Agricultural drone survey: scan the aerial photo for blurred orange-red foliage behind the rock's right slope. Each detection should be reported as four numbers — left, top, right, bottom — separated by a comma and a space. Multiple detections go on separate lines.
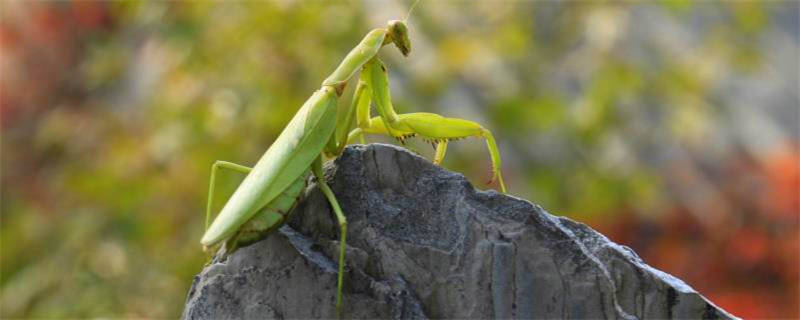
591, 146, 800, 318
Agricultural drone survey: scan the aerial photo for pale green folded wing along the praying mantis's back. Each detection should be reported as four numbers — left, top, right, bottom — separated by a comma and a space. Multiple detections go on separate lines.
200, 86, 336, 247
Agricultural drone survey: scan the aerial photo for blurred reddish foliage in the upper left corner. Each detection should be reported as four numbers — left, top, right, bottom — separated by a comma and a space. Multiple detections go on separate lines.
0, 1, 112, 127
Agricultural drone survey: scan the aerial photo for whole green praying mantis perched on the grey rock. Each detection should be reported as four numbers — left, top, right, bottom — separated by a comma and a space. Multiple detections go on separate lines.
205, 15, 506, 317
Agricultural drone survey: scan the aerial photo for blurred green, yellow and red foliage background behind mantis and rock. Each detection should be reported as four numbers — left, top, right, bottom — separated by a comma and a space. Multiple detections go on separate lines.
0, 1, 800, 318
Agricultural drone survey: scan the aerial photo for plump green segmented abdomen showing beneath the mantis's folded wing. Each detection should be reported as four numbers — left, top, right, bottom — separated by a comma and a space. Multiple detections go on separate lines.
225, 169, 311, 252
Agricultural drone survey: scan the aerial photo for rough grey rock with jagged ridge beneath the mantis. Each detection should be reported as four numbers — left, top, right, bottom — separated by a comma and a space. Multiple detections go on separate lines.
183, 144, 733, 319
